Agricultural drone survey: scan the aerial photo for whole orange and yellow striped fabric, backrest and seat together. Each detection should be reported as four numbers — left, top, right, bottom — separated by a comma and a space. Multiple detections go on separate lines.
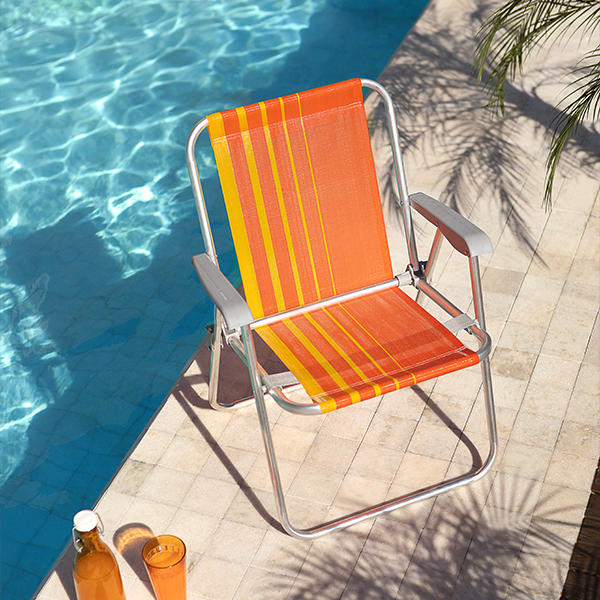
208, 79, 478, 412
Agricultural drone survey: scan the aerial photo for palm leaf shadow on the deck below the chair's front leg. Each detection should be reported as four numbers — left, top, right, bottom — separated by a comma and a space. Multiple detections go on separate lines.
263, 478, 577, 600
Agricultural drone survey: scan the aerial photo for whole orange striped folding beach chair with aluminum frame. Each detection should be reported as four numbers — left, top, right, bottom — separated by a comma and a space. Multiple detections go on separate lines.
187, 79, 497, 538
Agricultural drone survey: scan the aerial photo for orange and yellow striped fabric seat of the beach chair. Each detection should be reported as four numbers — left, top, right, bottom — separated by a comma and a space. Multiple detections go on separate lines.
256, 288, 479, 413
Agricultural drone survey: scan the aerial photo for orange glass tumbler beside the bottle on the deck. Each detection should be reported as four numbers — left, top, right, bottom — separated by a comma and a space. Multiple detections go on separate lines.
142, 535, 187, 600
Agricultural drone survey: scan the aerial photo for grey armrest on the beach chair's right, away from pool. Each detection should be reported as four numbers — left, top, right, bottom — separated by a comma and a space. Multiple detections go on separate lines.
409, 192, 494, 256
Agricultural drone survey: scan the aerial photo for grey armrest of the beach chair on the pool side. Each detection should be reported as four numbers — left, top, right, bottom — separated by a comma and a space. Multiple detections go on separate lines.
192, 254, 254, 329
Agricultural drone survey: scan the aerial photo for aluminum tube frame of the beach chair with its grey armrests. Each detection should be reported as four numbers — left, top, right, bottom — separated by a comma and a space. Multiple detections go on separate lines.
186, 79, 498, 539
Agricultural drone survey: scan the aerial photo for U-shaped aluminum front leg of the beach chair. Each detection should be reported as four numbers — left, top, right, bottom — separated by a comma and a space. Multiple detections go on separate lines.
242, 327, 498, 539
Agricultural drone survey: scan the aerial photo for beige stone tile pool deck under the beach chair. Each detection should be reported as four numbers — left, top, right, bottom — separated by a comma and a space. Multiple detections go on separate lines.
37, 0, 600, 600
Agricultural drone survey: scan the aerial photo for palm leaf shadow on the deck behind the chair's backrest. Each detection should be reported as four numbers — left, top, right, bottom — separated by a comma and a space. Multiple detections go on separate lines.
369, 2, 600, 260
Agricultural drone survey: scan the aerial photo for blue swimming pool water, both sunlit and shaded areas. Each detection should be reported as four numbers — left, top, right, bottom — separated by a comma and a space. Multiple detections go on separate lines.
0, 0, 426, 600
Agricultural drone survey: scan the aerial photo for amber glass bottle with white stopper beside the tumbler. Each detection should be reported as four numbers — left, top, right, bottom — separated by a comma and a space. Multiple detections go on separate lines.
73, 510, 125, 600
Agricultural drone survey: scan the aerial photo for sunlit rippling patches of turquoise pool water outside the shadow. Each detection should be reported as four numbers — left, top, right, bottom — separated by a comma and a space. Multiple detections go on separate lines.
0, 0, 324, 484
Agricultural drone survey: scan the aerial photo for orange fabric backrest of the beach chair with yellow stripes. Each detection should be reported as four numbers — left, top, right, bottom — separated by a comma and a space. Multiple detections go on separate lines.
207, 79, 393, 319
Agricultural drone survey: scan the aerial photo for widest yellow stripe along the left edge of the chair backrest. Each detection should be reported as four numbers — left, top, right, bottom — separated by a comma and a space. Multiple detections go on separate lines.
208, 113, 264, 318
